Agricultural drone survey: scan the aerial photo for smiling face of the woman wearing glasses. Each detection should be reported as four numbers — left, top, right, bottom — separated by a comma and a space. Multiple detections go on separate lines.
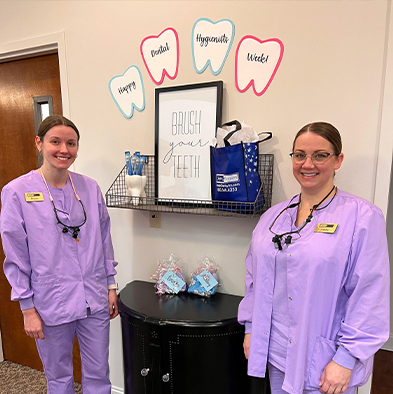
293, 132, 344, 195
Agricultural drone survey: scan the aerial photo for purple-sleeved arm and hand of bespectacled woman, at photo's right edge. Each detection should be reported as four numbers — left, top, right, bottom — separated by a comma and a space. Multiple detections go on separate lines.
320, 207, 389, 393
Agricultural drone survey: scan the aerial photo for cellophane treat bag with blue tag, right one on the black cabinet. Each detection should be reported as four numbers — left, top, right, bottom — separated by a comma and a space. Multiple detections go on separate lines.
188, 257, 218, 297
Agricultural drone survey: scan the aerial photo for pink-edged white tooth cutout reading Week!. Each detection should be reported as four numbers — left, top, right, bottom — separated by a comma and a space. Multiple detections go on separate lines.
235, 36, 284, 96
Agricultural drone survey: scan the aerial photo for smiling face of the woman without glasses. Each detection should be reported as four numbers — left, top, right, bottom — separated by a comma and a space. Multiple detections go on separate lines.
35, 125, 78, 171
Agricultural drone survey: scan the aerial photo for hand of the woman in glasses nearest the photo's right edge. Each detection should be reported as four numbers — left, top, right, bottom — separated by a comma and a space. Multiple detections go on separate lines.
319, 360, 352, 394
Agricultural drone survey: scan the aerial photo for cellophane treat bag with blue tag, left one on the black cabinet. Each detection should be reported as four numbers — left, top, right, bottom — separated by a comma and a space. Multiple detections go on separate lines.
150, 253, 187, 294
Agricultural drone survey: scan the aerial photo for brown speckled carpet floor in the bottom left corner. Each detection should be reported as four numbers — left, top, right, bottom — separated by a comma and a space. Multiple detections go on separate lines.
0, 361, 82, 394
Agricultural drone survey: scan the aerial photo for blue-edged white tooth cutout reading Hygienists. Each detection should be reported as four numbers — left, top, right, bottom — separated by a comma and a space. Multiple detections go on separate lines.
192, 18, 235, 75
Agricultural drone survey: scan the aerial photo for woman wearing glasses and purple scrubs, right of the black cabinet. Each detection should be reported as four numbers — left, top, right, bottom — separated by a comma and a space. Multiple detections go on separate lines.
238, 122, 389, 394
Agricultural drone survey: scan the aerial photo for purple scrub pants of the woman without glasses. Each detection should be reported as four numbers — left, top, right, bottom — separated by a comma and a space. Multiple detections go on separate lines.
36, 309, 111, 394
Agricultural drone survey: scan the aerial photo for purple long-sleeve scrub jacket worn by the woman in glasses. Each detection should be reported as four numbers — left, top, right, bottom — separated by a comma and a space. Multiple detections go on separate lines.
238, 190, 390, 394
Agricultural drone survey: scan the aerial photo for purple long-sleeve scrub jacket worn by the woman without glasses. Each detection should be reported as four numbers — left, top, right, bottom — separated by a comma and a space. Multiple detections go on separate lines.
0, 171, 117, 326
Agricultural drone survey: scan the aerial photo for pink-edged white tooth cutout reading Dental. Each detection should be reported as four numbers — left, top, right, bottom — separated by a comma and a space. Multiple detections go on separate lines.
140, 27, 179, 85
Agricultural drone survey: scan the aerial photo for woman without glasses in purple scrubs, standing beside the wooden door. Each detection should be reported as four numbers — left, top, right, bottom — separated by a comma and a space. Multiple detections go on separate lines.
0, 115, 118, 394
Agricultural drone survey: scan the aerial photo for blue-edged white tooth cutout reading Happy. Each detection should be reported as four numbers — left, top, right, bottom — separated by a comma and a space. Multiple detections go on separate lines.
109, 66, 145, 118
